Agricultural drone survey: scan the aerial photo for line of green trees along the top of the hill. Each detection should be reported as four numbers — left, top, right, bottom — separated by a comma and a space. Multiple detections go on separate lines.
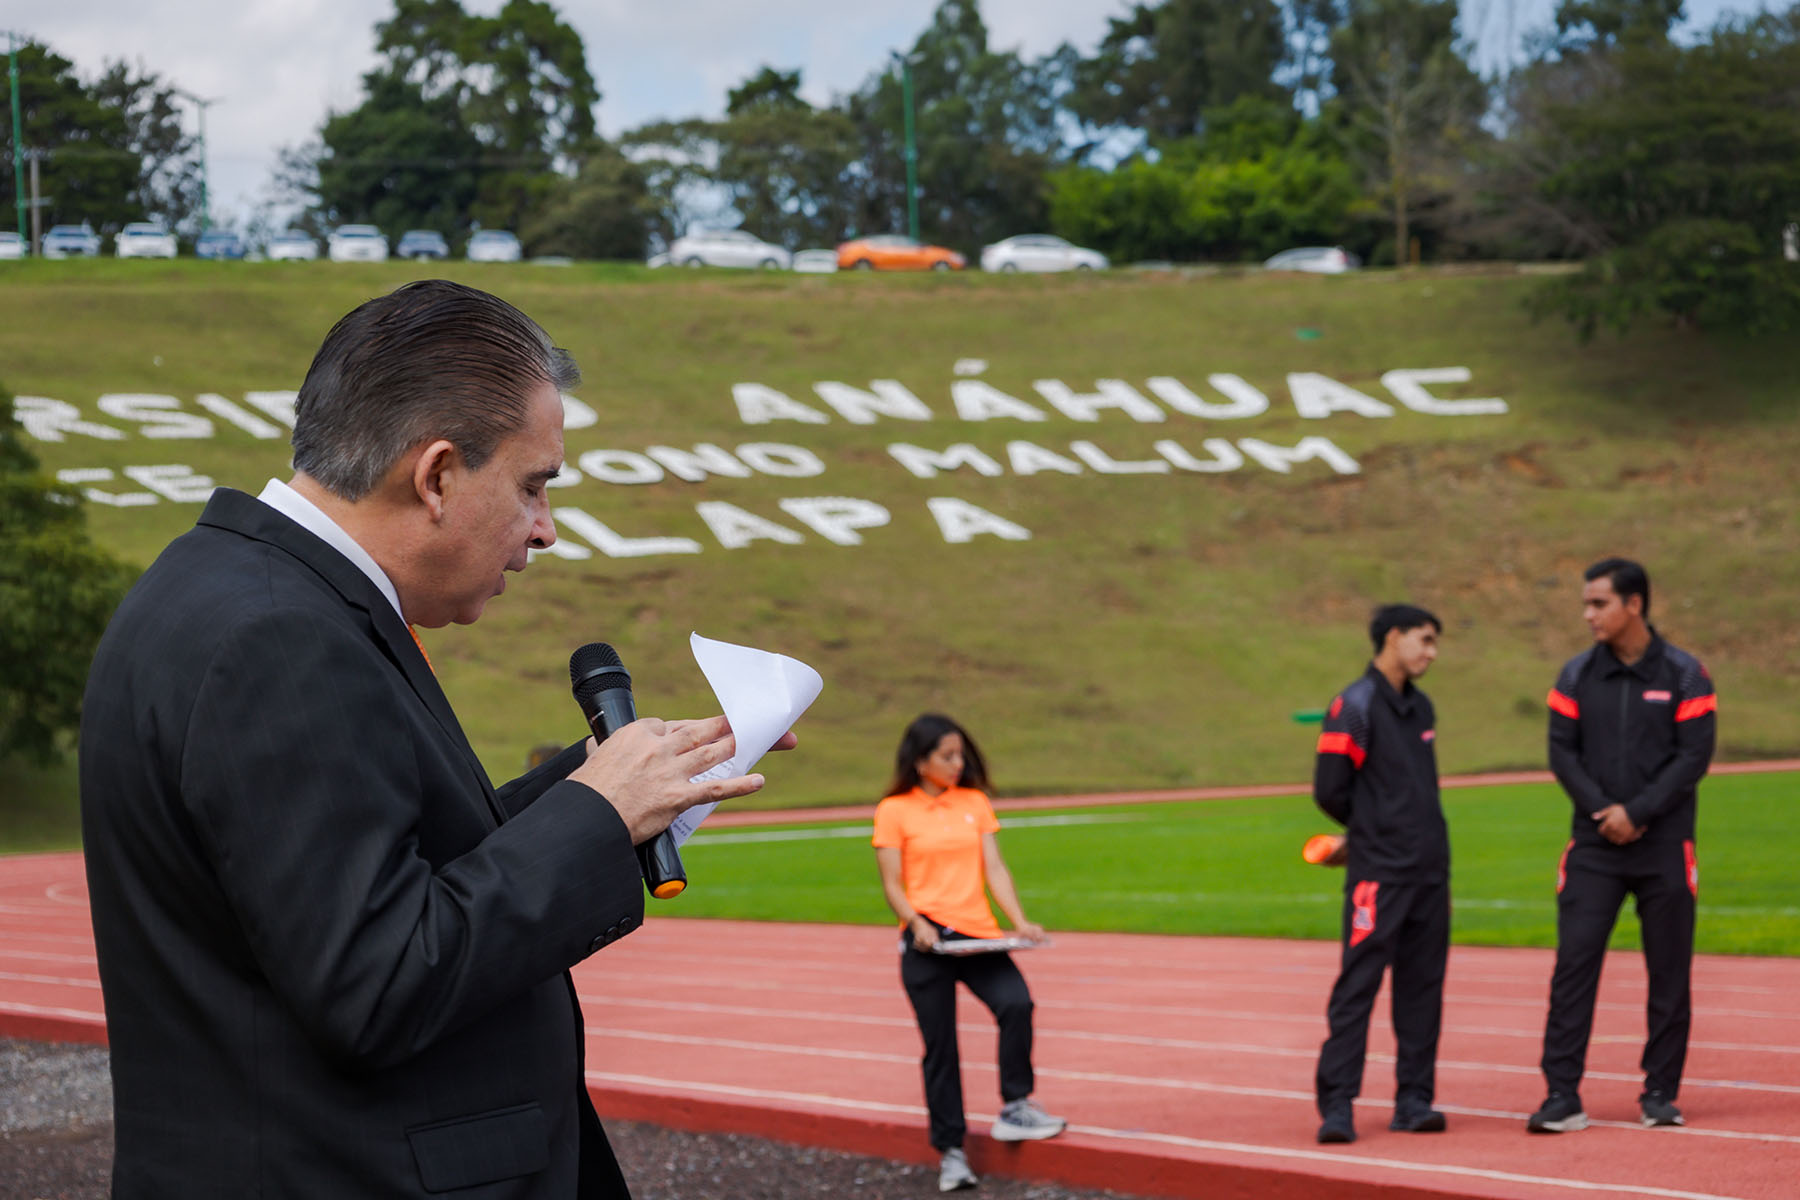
4, 0, 1800, 331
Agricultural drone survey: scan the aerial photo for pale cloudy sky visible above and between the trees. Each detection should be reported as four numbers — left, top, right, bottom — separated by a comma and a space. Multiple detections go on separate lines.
10, 0, 1775, 221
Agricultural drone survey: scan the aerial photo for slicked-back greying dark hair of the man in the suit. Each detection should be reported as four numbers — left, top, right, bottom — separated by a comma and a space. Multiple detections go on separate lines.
293, 279, 581, 500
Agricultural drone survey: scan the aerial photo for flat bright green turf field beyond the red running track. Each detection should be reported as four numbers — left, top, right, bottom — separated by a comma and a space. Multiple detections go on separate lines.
673, 774, 1800, 955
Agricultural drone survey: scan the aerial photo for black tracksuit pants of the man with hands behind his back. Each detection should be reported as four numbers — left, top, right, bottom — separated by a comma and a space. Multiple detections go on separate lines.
1314, 880, 1451, 1115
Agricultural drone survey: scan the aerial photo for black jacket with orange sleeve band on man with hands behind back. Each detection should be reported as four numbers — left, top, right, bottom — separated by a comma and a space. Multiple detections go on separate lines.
1312, 664, 1451, 883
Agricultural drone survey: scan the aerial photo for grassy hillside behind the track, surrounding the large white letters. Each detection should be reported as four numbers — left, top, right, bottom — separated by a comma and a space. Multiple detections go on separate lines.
0, 261, 1800, 840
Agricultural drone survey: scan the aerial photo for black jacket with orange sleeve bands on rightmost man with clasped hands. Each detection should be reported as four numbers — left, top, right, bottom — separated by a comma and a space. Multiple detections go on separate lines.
1548, 628, 1719, 851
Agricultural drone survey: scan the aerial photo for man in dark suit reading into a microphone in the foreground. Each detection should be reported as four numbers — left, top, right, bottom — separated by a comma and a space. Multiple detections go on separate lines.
81, 281, 790, 1200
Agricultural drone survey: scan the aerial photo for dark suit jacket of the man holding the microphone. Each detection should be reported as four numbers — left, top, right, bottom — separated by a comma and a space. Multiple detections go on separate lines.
81, 489, 644, 1200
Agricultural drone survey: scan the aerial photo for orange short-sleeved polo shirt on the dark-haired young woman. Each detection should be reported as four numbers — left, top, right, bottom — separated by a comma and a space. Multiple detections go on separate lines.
873, 788, 1001, 937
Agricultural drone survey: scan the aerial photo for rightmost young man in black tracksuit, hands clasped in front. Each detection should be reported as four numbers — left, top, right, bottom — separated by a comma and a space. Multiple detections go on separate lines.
1526, 558, 1717, 1133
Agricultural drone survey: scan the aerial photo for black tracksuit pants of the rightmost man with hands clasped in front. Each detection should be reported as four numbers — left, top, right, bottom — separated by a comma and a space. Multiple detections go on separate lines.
1543, 842, 1699, 1099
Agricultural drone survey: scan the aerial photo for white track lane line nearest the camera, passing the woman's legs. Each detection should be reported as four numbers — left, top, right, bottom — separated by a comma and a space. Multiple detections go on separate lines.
587, 1070, 1742, 1200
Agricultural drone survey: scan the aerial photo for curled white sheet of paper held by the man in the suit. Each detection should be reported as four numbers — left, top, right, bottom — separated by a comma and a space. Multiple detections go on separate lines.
670, 633, 824, 846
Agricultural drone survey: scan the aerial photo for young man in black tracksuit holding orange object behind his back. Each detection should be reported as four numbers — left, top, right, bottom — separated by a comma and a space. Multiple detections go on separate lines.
1312, 604, 1451, 1142
